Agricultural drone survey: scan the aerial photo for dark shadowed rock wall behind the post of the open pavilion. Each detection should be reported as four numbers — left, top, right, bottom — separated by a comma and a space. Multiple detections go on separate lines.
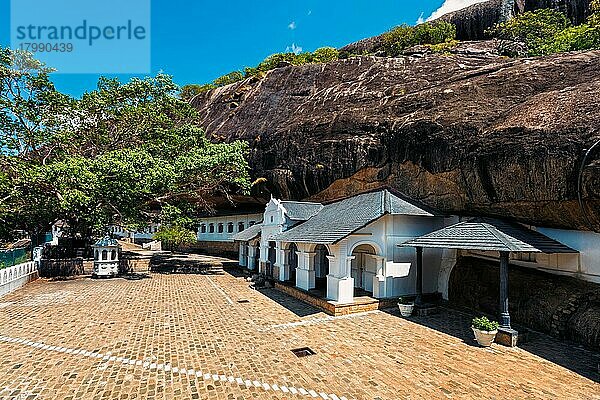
449, 257, 600, 350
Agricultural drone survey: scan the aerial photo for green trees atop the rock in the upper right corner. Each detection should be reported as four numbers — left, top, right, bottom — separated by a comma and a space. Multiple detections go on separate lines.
488, 5, 600, 56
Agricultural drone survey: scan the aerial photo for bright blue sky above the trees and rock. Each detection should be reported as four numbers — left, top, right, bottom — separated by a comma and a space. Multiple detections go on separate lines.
0, 0, 482, 96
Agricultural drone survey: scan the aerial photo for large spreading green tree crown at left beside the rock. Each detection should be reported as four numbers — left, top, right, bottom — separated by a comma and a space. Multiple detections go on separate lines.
0, 49, 249, 241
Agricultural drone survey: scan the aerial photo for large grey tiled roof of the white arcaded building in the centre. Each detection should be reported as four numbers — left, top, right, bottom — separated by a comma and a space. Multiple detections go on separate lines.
272, 190, 433, 244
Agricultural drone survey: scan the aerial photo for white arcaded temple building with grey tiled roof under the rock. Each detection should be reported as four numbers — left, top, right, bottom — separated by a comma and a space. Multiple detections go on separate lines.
234, 190, 455, 303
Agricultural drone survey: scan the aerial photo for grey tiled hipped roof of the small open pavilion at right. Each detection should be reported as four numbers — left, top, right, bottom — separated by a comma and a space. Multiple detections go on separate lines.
399, 218, 577, 254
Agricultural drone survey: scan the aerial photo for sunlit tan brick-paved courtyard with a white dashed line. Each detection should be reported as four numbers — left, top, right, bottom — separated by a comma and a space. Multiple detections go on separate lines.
0, 274, 600, 400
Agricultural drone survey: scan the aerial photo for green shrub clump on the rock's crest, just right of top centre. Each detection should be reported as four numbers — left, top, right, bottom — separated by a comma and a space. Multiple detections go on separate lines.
382, 21, 456, 57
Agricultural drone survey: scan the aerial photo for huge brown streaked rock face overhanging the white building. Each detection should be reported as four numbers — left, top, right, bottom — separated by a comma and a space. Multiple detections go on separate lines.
193, 42, 600, 230
